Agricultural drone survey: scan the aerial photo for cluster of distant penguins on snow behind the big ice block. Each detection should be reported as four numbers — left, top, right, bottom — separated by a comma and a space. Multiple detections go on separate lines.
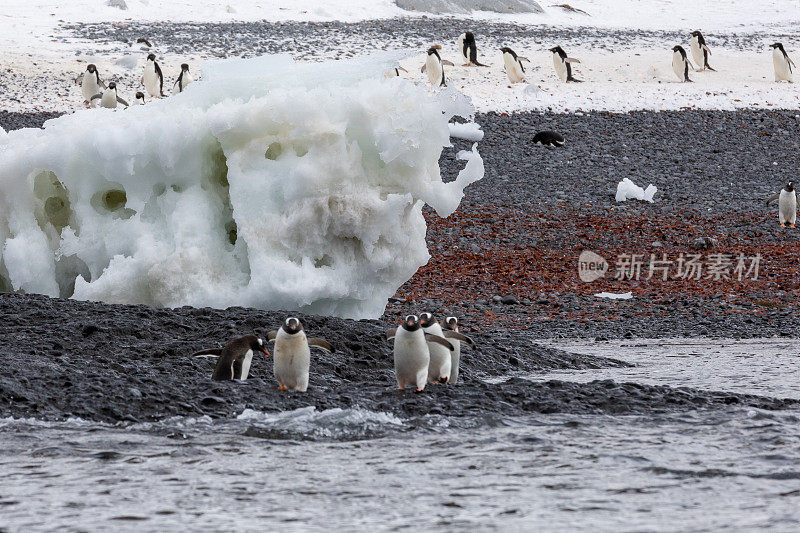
75, 53, 195, 109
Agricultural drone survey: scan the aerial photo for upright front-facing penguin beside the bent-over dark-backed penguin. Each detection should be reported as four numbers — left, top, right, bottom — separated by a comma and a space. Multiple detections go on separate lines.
267, 317, 333, 392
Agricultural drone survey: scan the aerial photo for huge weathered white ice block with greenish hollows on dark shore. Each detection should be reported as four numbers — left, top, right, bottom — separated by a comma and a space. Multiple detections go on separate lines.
0, 53, 483, 318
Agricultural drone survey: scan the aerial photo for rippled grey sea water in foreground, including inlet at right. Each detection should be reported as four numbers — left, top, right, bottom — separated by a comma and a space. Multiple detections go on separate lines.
0, 339, 800, 531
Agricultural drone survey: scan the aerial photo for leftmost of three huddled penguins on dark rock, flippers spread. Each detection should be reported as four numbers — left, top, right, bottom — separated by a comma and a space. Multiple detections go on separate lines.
386, 315, 453, 391
